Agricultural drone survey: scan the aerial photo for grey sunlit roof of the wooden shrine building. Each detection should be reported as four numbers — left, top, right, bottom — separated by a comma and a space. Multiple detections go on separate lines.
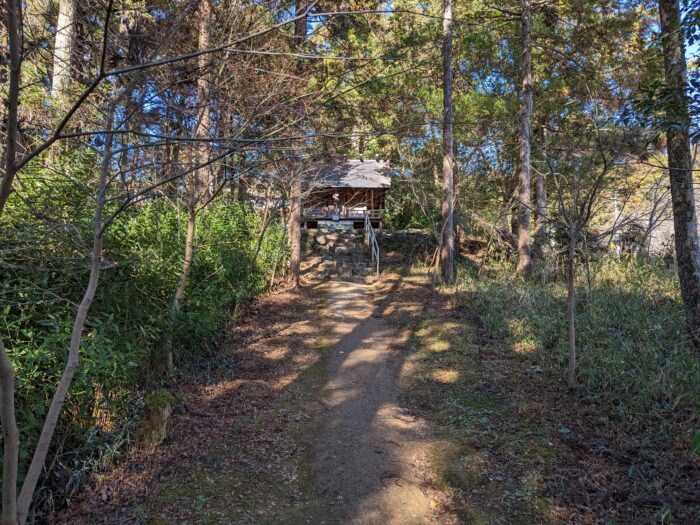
314, 159, 391, 189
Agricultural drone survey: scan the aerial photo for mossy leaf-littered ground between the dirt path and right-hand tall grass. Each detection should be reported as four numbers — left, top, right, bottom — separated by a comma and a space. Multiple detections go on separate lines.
394, 266, 700, 524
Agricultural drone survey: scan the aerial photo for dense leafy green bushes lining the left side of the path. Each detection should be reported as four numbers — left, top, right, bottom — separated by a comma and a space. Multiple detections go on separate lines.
0, 155, 287, 499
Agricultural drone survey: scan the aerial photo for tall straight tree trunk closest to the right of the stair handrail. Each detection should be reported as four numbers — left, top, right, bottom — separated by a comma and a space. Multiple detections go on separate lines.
440, 0, 455, 285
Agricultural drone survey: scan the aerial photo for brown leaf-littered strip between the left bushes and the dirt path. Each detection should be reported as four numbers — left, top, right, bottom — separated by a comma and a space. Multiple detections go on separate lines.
59, 286, 330, 525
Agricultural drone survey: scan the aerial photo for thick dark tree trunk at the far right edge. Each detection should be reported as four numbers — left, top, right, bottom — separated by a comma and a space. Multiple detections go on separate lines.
659, 0, 700, 350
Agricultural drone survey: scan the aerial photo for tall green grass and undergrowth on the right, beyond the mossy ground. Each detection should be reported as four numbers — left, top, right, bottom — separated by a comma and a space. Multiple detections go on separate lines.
460, 257, 700, 430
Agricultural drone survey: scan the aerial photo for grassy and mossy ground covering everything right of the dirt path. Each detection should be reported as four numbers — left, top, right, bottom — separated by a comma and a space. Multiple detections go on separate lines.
395, 253, 700, 524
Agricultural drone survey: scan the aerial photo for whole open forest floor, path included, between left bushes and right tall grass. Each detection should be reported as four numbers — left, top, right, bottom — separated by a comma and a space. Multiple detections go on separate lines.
56, 258, 699, 525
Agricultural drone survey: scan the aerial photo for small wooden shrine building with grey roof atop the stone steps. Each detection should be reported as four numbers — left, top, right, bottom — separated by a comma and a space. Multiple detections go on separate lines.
302, 159, 391, 228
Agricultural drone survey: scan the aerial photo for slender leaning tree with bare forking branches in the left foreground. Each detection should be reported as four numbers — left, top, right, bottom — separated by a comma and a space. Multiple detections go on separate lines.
0, 0, 318, 525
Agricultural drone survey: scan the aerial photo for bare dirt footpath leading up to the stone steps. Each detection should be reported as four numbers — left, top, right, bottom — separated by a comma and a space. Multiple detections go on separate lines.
311, 281, 432, 525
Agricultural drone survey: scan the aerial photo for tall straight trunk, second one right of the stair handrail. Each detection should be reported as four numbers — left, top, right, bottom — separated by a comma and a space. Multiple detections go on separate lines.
518, 0, 532, 275
